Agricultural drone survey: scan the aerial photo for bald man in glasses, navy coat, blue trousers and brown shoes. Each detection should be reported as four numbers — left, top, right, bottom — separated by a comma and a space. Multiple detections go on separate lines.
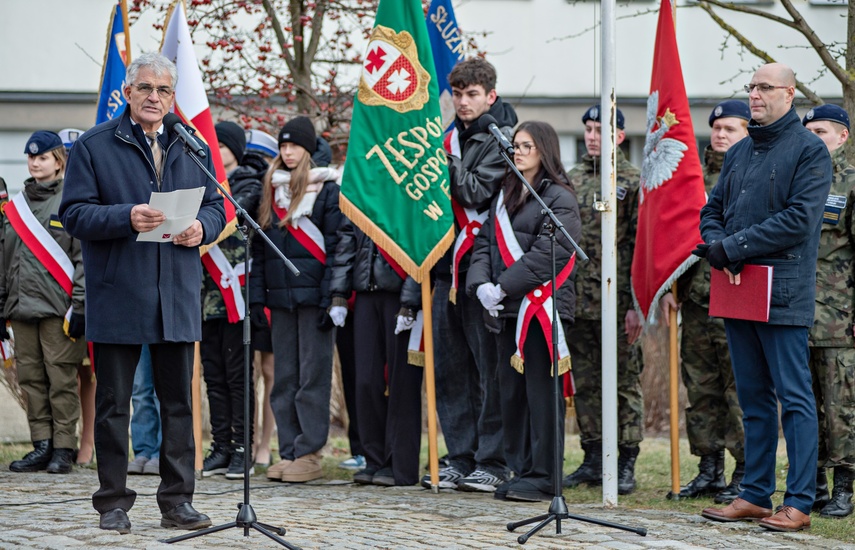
696, 63, 831, 531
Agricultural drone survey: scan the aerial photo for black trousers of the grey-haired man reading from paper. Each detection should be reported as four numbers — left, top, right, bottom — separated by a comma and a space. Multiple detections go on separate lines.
92, 343, 196, 513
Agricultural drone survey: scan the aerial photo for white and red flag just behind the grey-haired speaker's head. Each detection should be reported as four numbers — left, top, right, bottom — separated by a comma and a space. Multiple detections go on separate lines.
160, 0, 237, 236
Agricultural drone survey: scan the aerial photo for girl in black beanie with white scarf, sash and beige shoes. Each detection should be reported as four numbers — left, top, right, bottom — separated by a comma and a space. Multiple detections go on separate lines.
249, 117, 342, 483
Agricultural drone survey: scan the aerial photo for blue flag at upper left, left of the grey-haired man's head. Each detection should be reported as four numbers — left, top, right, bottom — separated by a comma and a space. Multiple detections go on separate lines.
95, 2, 129, 124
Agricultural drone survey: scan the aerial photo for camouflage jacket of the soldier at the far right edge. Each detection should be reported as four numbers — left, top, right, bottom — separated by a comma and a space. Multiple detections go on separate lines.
809, 147, 855, 347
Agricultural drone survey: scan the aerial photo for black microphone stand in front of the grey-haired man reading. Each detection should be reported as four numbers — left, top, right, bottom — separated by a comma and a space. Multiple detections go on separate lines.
162, 143, 300, 550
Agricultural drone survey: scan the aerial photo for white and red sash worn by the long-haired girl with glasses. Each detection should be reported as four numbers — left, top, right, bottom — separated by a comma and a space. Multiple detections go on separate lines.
496, 191, 576, 382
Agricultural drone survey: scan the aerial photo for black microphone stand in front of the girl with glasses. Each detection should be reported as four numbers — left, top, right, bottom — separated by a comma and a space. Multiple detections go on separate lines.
488, 144, 647, 544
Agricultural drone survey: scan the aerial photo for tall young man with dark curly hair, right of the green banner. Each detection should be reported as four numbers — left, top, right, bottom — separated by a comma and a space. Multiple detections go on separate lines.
422, 58, 517, 492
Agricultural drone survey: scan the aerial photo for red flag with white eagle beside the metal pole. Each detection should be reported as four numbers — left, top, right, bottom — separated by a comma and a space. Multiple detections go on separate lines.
632, 0, 706, 320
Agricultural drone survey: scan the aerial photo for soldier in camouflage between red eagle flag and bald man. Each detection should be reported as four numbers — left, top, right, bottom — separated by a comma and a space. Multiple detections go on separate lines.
660, 99, 751, 504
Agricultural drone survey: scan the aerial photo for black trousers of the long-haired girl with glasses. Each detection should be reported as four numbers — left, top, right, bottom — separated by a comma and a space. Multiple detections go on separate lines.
499, 320, 564, 493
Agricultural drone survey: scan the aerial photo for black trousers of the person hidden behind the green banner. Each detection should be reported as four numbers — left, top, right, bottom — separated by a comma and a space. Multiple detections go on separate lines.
353, 292, 422, 485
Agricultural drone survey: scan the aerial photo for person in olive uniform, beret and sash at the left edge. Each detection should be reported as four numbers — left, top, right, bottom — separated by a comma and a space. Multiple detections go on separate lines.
0, 130, 86, 474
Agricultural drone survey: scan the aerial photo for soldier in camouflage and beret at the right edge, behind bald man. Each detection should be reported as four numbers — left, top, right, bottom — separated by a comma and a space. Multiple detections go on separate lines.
802, 105, 855, 518
